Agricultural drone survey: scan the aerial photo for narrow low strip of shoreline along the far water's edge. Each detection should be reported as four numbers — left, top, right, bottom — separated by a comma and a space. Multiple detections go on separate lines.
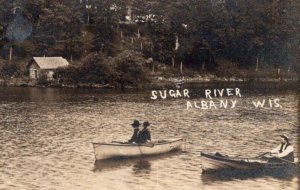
0, 76, 299, 89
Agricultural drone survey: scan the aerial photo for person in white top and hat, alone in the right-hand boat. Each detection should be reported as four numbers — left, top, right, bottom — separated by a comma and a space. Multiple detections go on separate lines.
266, 135, 294, 162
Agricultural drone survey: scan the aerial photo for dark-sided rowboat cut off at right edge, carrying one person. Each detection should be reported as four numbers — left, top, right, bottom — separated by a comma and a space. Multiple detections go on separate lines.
201, 152, 298, 172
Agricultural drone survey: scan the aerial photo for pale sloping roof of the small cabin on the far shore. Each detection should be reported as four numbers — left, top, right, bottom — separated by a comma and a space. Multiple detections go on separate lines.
33, 57, 69, 69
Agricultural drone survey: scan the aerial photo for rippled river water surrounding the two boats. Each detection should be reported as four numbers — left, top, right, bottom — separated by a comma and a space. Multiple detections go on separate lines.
0, 85, 299, 190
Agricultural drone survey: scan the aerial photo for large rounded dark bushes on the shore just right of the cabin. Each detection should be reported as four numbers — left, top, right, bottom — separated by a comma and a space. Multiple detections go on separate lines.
54, 51, 149, 88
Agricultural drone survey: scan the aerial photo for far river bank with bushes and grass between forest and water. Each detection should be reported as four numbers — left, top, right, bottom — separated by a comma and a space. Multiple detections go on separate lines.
0, 50, 299, 88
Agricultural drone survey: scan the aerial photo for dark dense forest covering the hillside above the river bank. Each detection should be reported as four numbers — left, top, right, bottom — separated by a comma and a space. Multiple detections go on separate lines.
0, 0, 300, 72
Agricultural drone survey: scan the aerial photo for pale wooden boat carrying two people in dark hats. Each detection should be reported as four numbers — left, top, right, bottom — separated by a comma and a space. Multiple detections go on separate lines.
93, 138, 184, 160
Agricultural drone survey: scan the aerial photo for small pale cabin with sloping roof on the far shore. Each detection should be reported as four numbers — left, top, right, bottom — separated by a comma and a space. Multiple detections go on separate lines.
27, 57, 69, 80
